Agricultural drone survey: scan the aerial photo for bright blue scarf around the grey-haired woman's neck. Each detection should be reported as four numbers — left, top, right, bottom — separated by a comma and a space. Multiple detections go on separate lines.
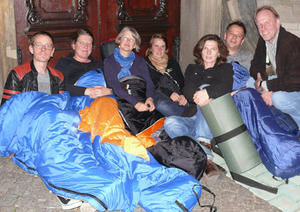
114, 48, 135, 80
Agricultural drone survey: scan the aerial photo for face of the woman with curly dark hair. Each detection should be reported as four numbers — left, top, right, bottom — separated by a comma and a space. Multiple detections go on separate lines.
201, 40, 220, 69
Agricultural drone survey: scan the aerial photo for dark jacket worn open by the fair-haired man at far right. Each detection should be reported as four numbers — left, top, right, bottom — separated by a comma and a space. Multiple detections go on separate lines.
250, 27, 300, 92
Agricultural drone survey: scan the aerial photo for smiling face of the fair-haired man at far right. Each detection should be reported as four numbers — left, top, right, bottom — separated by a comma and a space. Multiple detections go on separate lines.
255, 10, 280, 43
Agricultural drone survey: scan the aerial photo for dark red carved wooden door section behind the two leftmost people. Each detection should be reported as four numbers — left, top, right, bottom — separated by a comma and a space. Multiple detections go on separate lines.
14, 0, 99, 65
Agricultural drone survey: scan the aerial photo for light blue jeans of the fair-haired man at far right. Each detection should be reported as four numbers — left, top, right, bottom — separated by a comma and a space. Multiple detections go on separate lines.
247, 76, 300, 128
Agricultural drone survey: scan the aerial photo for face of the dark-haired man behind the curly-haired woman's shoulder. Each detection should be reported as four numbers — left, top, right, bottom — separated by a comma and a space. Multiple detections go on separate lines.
224, 25, 244, 54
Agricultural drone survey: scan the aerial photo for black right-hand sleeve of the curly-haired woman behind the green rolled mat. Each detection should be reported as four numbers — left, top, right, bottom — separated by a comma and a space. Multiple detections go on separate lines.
206, 63, 233, 98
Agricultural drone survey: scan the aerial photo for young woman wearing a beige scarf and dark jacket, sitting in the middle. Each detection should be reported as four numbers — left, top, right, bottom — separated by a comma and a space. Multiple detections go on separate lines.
146, 33, 187, 116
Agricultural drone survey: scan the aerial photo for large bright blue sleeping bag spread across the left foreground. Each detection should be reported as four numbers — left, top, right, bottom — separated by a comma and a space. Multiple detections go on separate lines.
0, 92, 201, 212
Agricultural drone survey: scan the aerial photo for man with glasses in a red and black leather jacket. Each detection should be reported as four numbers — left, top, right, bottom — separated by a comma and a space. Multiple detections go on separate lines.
1, 31, 65, 105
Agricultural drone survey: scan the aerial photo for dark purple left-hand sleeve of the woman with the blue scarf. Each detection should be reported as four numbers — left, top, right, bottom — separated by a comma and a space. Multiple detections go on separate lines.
104, 56, 139, 106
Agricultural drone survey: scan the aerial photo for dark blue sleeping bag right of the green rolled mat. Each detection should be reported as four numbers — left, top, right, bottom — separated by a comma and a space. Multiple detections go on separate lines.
233, 88, 300, 178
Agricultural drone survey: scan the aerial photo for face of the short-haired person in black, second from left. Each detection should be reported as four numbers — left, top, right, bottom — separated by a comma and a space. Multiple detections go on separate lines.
72, 34, 93, 62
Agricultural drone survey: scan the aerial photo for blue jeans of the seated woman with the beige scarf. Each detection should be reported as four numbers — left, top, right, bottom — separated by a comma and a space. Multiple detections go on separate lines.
154, 91, 187, 117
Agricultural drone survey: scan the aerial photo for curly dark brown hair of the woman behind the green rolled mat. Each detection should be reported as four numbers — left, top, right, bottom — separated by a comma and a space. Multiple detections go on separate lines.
193, 34, 228, 65
